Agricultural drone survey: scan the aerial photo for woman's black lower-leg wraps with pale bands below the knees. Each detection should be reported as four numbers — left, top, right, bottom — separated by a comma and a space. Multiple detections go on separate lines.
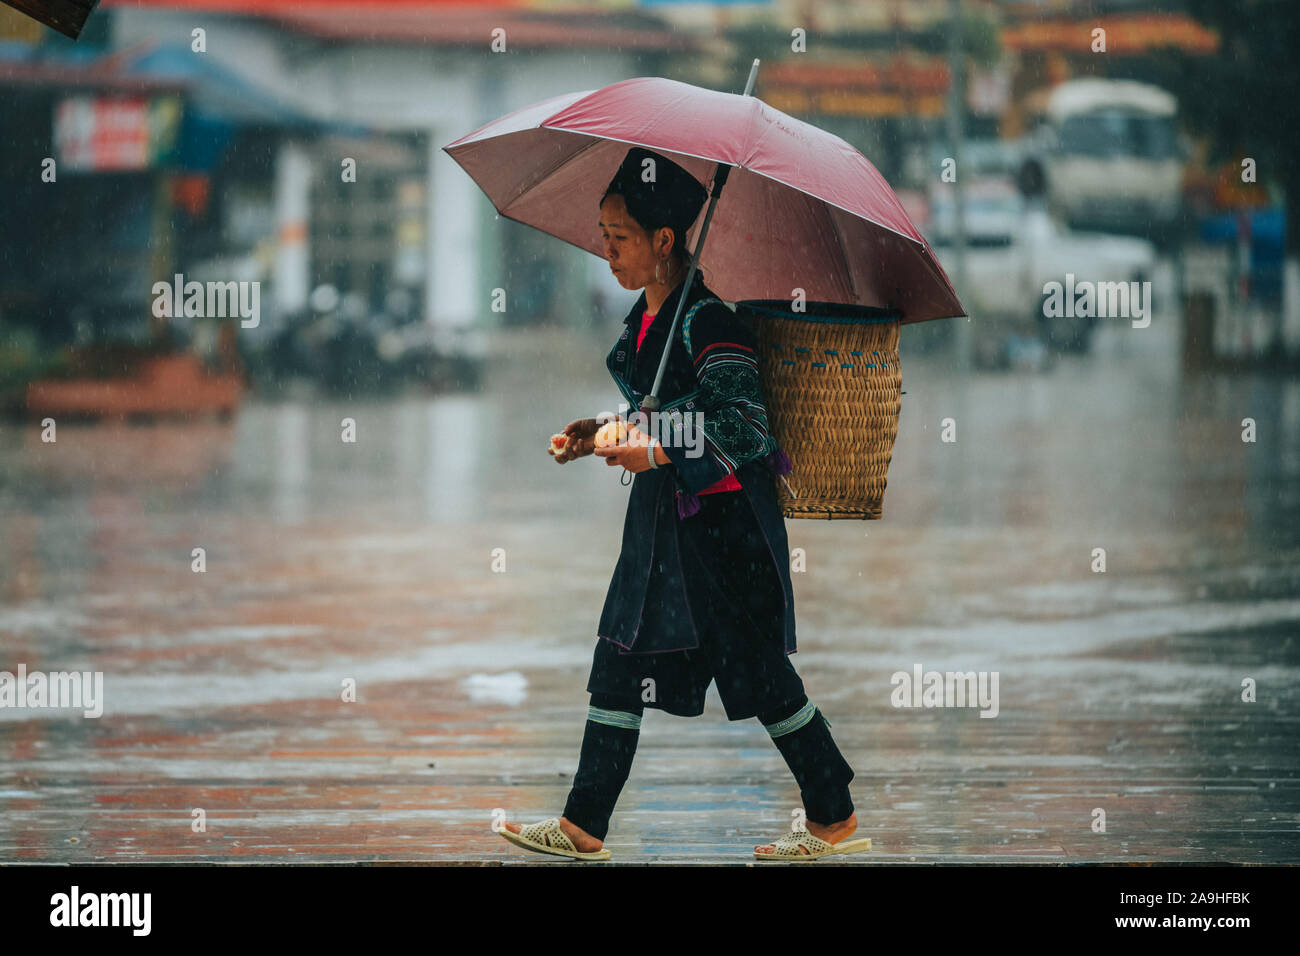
564, 693, 853, 840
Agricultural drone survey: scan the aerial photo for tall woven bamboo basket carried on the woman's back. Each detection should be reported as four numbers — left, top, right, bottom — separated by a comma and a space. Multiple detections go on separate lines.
736, 299, 902, 519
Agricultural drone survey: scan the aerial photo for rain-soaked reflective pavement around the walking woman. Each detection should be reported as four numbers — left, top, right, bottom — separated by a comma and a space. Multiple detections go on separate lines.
0, 310, 1300, 865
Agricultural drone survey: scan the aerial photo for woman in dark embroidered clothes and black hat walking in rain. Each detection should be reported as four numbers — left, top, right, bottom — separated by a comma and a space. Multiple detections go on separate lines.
498, 147, 871, 861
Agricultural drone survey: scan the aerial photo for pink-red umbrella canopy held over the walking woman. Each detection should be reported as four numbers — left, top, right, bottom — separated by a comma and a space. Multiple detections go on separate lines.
443, 77, 965, 323
